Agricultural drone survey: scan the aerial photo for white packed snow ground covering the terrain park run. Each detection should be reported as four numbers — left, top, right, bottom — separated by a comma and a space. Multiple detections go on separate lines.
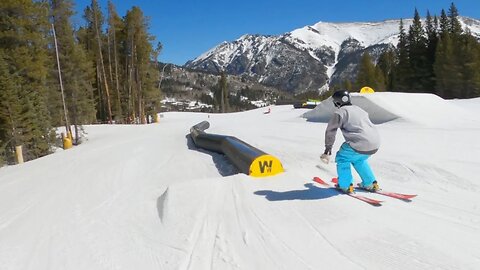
0, 93, 480, 270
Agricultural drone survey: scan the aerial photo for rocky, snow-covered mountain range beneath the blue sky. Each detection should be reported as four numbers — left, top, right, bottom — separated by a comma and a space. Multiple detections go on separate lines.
185, 17, 480, 93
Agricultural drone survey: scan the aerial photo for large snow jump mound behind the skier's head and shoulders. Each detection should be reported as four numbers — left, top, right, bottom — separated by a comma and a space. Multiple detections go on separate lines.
303, 92, 477, 126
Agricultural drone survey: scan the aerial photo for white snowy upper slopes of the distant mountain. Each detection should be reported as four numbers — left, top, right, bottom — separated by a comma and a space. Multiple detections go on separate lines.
192, 17, 480, 66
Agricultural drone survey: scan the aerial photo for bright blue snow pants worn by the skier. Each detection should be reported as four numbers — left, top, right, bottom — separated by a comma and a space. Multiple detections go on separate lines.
335, 143, 375, 188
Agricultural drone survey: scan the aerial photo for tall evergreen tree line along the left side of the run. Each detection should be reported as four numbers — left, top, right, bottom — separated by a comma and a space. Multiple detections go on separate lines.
0, 0, 162, 165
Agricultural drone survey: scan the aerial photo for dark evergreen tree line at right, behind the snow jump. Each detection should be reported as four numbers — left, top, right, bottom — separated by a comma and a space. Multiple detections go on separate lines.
342, 3, 480, 99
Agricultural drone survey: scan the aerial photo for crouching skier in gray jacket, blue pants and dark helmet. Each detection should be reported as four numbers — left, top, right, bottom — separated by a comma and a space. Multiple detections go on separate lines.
320, 90, 380, 193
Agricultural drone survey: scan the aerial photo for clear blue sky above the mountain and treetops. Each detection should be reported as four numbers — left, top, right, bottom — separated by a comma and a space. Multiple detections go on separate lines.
74, 0, 480, 65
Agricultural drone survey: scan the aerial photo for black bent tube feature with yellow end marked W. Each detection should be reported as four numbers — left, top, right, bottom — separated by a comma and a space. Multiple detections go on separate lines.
190, 121, 283, 177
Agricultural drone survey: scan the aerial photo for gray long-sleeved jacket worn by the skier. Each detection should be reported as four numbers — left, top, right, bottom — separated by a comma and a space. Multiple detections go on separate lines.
325, 105, 380, 155
